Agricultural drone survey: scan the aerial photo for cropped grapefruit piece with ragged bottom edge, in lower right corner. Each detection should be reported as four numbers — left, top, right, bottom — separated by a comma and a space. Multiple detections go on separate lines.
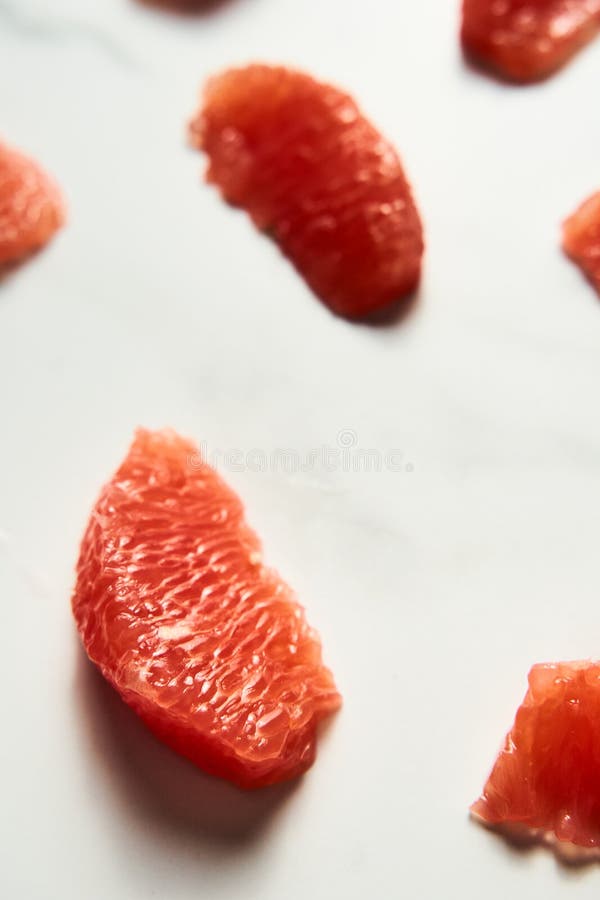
471, 662, 600, 858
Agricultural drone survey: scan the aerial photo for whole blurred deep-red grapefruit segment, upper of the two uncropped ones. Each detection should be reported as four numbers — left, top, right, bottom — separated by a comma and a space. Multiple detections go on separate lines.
190, 65, 423, 317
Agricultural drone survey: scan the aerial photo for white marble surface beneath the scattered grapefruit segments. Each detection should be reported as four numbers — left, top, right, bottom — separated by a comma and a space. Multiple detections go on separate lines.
0, 0, 600, 900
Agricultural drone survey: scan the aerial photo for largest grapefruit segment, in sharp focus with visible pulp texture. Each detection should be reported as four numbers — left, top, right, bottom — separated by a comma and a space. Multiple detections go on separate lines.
72, 430, 340, 787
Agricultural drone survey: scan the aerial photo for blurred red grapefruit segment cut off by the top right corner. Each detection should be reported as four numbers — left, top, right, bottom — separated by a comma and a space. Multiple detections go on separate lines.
461, 0, 600, 82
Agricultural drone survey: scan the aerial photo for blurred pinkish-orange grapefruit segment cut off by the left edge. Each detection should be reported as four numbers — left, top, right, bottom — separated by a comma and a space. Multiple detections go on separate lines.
0, 144, 64, 266
